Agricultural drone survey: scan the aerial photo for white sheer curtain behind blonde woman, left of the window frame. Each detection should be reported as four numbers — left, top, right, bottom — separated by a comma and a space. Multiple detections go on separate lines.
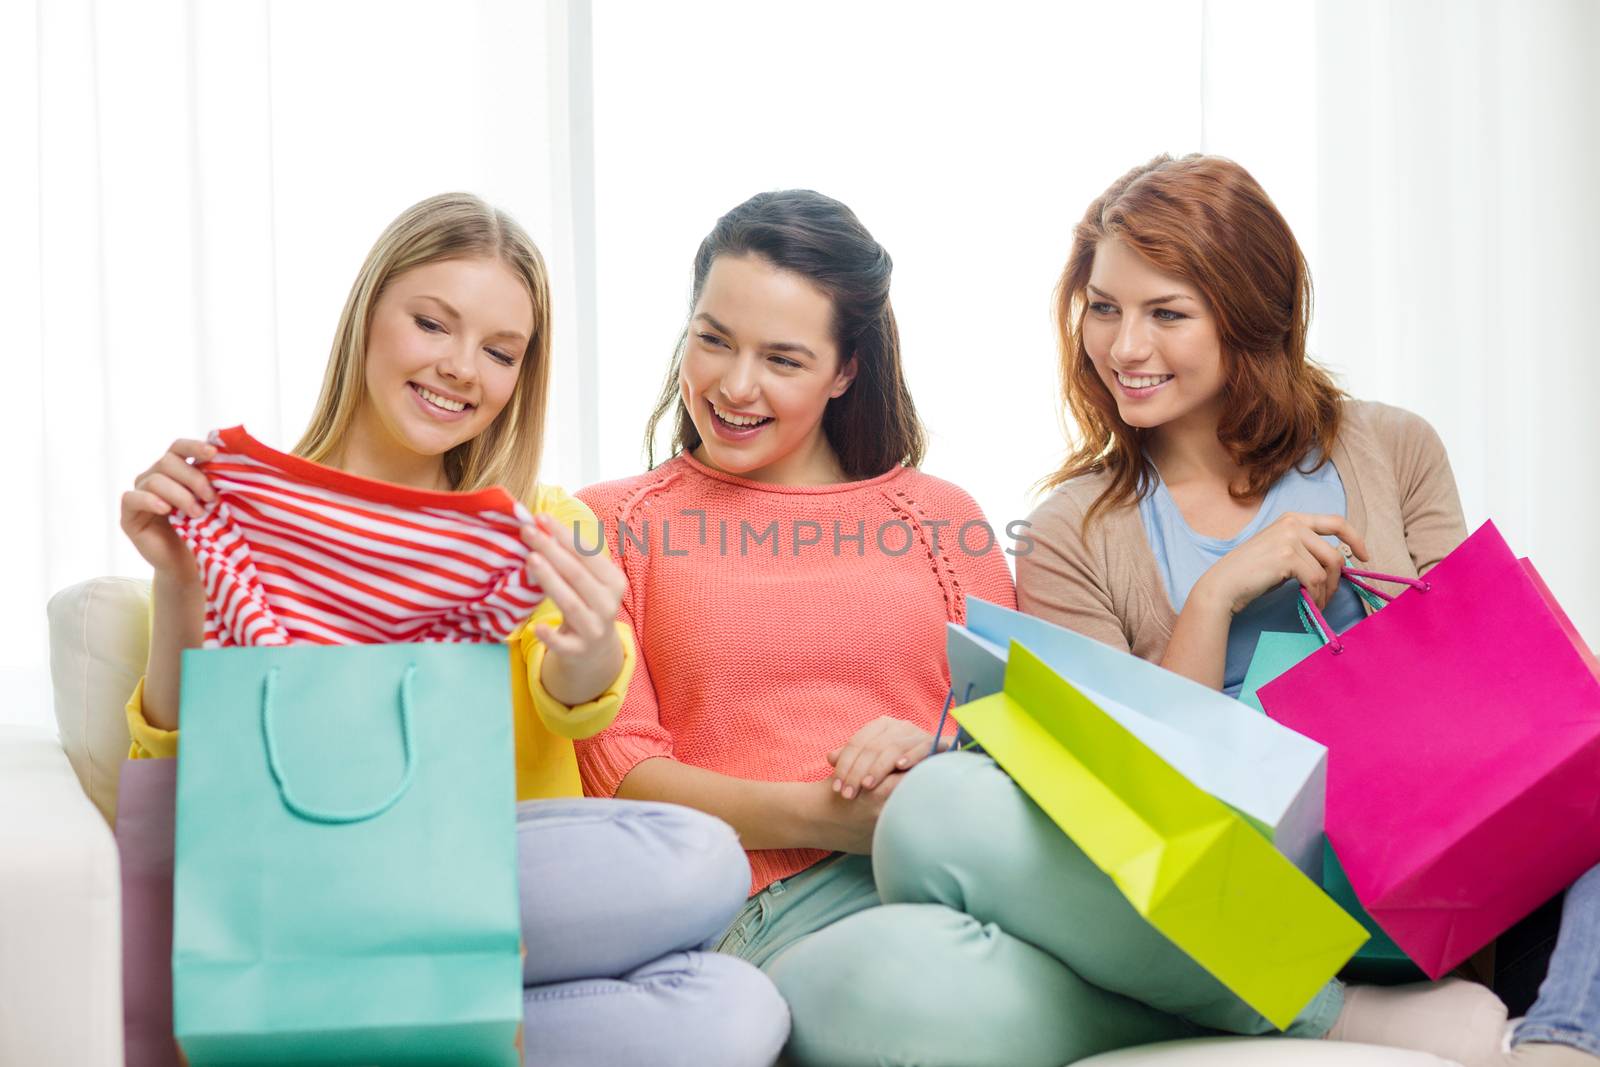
0, 0, 598, 721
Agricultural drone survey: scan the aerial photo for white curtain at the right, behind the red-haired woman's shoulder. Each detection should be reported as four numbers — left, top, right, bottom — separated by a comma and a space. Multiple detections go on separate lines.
1314, 0, 1600, 646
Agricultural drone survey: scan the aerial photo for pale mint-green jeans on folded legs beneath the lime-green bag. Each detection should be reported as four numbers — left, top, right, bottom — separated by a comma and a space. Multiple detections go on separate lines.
720, 752, 1344, 1067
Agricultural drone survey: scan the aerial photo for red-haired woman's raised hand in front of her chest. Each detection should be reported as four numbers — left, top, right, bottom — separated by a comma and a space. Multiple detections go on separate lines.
1190, 512, 1366, 617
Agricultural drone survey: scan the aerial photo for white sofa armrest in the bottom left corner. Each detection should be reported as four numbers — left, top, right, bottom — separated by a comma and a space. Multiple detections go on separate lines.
0, 726, 123, 1067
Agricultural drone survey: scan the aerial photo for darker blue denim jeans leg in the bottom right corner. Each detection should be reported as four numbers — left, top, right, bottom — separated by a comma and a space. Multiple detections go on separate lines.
1512, 867, 1600, 1056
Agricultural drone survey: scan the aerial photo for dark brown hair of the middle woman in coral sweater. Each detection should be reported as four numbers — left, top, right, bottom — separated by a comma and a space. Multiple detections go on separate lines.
645, 189, 925, 478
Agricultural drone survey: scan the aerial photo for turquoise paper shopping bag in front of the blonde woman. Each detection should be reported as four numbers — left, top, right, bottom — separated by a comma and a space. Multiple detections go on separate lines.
173, 643, 522, 1067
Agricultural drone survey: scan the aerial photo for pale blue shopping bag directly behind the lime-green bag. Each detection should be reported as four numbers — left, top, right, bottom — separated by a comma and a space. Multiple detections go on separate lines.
946, 597, 1328, 878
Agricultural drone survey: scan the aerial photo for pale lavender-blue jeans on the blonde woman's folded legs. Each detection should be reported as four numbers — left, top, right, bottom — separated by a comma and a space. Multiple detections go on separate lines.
517, 798, 789, 1067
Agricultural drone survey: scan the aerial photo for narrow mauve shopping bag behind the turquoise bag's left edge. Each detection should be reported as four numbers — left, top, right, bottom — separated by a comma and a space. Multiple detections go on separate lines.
117, 760, 181, 1067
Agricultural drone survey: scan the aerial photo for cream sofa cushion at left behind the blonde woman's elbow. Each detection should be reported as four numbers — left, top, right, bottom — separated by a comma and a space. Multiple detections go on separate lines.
48, 577, 150, 822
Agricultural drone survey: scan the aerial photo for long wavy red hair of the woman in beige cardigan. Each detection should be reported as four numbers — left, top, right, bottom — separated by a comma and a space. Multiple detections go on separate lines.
1042, 155, 1344, 517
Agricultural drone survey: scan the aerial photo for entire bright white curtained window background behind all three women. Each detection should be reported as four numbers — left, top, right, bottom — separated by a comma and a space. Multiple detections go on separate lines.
0, 0, 1600, 721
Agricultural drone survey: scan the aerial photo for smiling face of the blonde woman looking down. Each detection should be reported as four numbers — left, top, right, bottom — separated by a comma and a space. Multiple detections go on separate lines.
347, 258, 533, 480
